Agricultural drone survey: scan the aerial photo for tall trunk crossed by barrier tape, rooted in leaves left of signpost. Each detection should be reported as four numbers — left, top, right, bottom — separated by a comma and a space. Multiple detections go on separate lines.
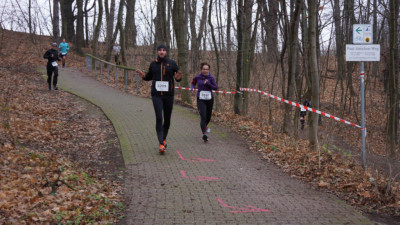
308, 0, 319, 151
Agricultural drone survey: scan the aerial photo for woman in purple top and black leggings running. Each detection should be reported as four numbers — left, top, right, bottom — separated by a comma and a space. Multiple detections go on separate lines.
190, 62, 218, 142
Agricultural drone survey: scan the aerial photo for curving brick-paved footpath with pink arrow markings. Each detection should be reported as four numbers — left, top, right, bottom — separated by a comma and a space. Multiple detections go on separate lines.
59, 68, 373, 225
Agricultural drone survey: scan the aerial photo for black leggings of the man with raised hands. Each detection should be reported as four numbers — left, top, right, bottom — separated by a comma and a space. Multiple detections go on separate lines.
152, 95, 174, 144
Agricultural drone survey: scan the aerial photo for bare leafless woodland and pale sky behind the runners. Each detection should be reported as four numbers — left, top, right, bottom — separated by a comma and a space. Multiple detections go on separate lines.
0, 0, 400, 158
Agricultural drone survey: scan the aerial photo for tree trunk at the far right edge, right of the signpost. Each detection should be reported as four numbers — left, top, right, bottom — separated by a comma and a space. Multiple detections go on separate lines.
387, 0, 399, 158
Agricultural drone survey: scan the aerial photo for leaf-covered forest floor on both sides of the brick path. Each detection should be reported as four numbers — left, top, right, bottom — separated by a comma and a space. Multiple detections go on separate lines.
0, 31, 400, 224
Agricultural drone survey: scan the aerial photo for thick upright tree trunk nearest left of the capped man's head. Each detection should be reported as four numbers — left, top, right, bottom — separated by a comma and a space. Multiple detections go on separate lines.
125, 0, 137, 48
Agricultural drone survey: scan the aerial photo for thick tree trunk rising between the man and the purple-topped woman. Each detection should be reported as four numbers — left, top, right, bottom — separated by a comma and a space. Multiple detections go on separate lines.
172, 0, 192, 104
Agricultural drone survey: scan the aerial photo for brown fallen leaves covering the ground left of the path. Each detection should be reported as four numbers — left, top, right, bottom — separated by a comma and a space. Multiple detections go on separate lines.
0, 30, 124, 224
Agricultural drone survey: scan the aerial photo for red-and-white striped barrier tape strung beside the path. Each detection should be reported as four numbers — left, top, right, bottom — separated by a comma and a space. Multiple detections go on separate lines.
175, 87, 360, 130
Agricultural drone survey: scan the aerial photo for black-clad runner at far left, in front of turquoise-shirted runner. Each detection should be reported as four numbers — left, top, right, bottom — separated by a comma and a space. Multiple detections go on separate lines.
43, 42, 60, 90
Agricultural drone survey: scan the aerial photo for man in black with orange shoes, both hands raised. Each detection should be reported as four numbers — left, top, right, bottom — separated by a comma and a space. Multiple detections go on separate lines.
136, 44, 182, 154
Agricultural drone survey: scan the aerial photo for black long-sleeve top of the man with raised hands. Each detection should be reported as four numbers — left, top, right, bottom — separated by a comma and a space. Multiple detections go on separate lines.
143, 58, 181, 96
